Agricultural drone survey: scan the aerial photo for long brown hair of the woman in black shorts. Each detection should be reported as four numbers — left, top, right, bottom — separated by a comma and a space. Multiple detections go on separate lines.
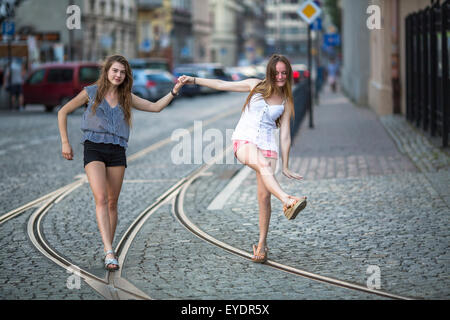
92, 54, 133, 126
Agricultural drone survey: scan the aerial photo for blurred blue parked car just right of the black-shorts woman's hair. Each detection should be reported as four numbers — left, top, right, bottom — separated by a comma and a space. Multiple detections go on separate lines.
132, 69, 176, 101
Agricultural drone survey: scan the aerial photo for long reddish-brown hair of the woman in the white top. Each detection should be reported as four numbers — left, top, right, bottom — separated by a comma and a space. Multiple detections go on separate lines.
242, 54, 295, 127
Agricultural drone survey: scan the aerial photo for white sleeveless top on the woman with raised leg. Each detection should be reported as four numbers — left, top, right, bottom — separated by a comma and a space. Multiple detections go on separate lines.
231, 93, 285, 153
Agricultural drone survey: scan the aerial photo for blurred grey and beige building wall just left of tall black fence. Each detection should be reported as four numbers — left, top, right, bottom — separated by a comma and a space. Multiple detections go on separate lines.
341, 0, 430, 115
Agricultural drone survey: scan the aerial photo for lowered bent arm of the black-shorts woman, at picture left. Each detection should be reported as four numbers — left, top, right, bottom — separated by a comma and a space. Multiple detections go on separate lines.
58, 90, 89, 160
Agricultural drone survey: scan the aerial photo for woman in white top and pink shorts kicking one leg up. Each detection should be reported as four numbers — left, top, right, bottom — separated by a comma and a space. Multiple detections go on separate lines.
179, 54, 306, 263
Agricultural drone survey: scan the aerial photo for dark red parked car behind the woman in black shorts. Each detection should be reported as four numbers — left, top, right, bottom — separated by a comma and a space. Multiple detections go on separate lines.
23, 62, 100, 112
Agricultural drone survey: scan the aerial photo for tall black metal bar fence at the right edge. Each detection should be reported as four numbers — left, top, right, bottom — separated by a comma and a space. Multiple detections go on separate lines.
405, 0, 450, 147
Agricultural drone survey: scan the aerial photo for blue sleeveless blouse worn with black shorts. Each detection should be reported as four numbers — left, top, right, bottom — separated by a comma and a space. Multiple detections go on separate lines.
81, 85, 130, 149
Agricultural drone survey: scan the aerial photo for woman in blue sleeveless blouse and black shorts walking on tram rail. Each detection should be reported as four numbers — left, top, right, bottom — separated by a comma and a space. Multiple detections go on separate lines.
58, 55, 182, 271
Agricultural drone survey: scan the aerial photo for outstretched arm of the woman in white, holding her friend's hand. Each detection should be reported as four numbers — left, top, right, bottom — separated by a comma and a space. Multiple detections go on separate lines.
179, 75, 261, 92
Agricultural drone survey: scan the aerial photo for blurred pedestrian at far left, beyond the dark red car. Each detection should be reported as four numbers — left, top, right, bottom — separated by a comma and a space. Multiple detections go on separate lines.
3, 58, 25, 111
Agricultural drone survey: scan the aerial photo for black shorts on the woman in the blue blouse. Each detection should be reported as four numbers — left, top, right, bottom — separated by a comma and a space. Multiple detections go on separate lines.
84, 140, 127, 168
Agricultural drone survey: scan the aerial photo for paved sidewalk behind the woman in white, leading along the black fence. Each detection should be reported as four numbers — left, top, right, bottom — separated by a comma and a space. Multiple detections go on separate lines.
291, 91, 450, 207
